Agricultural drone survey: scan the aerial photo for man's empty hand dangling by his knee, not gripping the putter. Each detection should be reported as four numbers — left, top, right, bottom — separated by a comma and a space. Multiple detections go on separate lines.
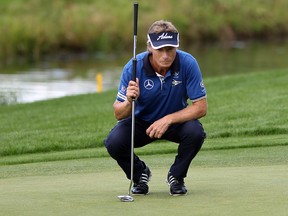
146, 117, 171, 139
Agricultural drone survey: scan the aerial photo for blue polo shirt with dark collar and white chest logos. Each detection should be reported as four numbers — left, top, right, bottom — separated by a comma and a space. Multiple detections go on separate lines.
116, 50, 206, 123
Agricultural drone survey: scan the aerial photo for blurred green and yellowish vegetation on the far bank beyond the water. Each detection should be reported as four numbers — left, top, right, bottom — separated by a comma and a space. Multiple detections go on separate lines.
0, 0, 288, 62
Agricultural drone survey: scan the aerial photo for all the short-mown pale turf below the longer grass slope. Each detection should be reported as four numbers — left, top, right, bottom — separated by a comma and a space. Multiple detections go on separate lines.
0, 146, 288, 216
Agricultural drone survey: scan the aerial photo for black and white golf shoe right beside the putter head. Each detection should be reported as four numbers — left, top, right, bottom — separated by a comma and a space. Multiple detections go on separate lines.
131, 166, 152, 195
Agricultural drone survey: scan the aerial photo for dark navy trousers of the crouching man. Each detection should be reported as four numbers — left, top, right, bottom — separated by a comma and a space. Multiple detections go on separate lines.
104, 118, 206, 182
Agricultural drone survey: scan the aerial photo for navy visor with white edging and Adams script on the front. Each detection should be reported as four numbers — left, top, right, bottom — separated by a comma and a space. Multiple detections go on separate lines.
147, 32, 179, 49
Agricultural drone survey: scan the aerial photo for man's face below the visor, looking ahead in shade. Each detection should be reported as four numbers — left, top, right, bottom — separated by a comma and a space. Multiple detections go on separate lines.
149, 46, 176, 68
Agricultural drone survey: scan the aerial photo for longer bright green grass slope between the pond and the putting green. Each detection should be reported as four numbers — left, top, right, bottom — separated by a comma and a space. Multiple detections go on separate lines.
0, 70, 288, 164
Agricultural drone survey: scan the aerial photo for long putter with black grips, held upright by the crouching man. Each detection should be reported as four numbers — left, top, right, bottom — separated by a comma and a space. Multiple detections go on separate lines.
118, 2, 138, 202
